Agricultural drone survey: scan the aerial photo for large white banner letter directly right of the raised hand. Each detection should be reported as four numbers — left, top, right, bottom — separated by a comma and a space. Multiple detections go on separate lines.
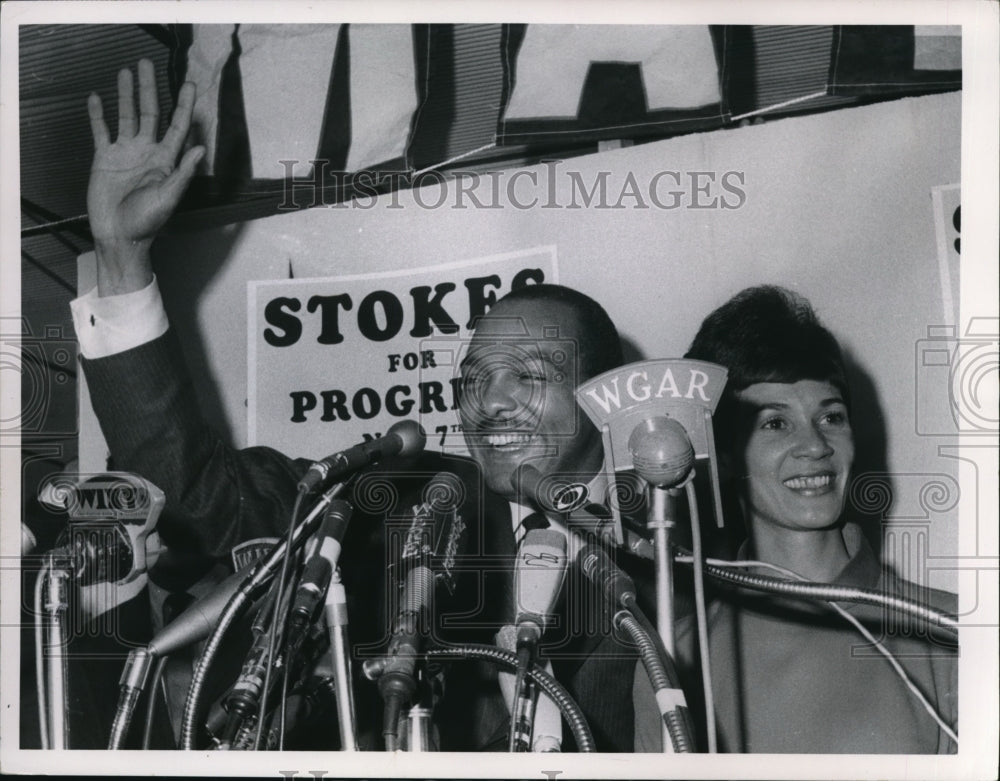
186, 24, 417, 179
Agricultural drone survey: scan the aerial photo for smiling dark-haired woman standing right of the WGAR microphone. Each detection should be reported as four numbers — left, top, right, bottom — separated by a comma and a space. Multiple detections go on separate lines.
635, 287, 958, 754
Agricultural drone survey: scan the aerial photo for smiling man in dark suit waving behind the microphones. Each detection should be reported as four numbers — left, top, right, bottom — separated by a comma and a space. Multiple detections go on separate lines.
73, 61, 648, 751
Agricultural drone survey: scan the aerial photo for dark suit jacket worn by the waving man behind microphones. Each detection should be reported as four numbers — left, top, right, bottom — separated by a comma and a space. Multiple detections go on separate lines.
82, 331, 636, 751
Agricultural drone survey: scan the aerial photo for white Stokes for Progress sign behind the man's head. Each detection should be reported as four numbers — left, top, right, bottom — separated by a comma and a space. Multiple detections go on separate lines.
247, 247, 558, 458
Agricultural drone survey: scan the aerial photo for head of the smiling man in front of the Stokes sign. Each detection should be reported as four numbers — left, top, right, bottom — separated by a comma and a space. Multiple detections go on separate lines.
459, 285, 622, 501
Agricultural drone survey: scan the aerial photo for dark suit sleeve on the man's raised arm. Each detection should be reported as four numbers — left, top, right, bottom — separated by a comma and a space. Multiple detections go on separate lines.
81, 330, 308, 556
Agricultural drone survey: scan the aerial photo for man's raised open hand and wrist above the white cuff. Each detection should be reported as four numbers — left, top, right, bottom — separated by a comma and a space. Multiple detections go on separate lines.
87, 60, 205, 296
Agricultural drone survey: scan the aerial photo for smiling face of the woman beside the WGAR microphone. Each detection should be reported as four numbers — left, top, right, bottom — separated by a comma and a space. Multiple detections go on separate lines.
737, 380, 854, 530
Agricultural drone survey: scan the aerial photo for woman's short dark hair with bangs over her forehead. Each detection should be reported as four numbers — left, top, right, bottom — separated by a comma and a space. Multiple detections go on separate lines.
685, 285, 849, 404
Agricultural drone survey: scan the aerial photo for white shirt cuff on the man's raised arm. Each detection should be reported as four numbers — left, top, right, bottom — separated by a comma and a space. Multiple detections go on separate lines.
69, 276, 169, 358
